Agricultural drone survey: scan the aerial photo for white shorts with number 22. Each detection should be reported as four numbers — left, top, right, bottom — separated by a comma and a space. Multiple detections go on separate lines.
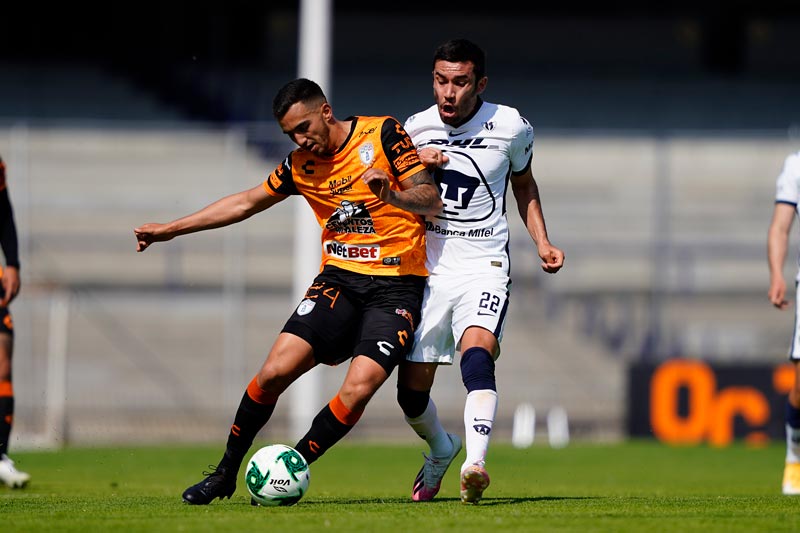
406, 275, 511, 365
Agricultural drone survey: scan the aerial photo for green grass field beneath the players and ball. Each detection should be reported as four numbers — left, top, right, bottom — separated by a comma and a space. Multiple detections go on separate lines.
0, 442, 800, 533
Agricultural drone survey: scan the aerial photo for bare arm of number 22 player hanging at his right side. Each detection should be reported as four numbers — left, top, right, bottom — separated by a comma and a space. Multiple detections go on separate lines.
511, 167, 564, 274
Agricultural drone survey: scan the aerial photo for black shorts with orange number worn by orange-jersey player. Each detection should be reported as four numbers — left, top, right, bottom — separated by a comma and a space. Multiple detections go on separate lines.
282, 266, 425, 374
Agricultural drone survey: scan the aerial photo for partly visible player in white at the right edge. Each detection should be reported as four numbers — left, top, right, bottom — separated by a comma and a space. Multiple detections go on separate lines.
767, 152, 800, 494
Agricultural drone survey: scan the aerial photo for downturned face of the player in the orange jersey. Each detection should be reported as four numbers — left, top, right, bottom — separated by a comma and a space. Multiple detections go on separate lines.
278, 102, 337, 156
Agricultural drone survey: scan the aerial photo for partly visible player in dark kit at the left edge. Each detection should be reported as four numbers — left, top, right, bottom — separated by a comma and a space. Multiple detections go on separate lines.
0, 154, 31, 488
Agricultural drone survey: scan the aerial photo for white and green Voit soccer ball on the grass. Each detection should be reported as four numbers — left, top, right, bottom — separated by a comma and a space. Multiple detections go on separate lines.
244, 444, 311, 506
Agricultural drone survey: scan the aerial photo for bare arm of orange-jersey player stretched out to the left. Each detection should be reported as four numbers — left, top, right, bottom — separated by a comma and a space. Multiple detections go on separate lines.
133, 185, 285, 252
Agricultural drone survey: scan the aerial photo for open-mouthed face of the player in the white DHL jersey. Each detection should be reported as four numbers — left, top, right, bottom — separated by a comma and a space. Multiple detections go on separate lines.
433, 61, 487, 126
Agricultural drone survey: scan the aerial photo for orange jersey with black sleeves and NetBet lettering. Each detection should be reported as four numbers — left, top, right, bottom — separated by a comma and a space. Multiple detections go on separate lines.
264, 117, 428, 276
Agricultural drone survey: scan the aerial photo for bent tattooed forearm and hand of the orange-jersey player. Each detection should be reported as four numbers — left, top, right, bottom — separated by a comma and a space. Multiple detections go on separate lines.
361, 168, 443, 216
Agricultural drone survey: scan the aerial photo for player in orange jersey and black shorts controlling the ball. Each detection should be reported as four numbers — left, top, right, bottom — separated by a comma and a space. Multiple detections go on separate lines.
134, 79, 442, 505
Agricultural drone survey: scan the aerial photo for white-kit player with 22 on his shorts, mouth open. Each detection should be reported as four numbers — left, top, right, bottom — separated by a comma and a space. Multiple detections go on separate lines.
397, 39, 564, 503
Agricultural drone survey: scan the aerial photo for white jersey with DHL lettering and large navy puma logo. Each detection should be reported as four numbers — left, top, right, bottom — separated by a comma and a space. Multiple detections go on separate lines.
404, 102, 533, 276
